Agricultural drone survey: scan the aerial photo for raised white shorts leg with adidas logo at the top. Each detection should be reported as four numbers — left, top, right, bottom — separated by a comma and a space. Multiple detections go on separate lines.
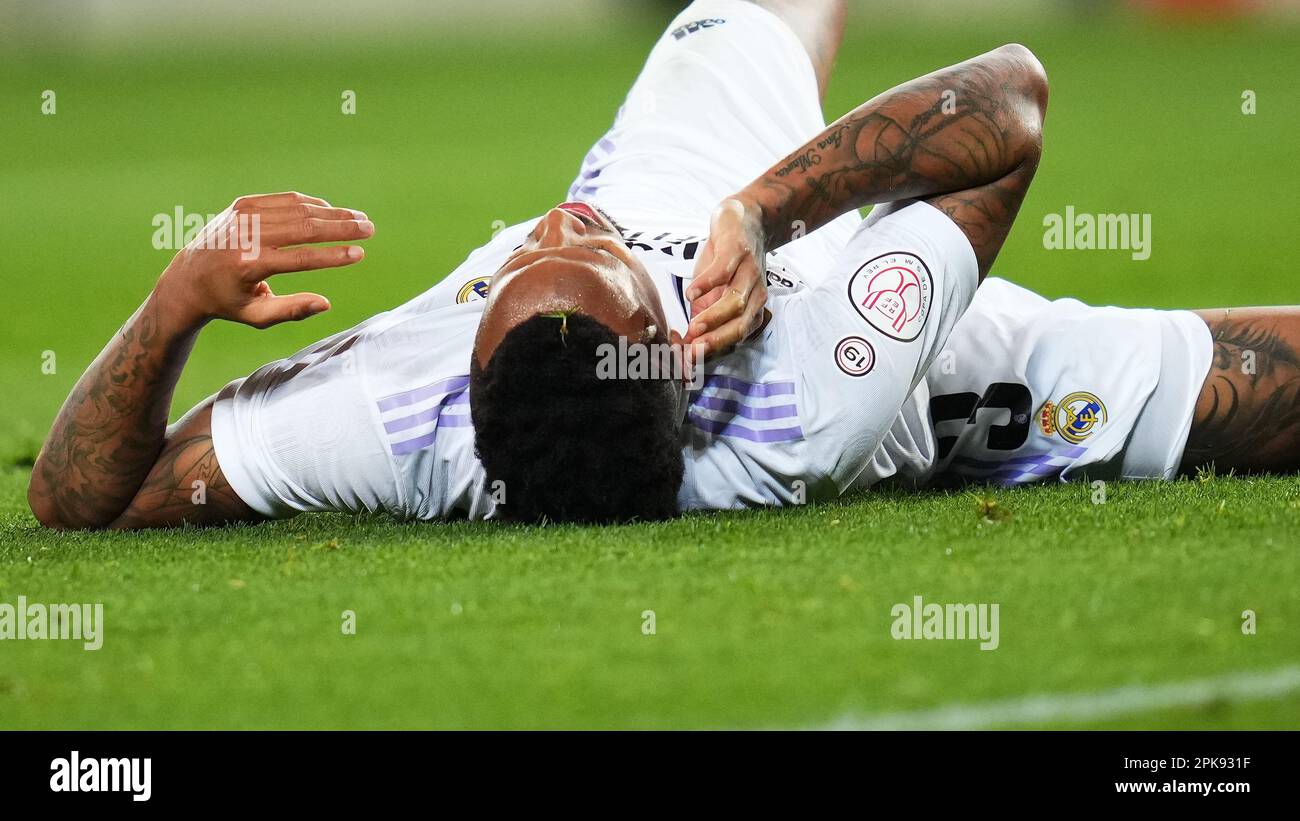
568, 0, 859, 270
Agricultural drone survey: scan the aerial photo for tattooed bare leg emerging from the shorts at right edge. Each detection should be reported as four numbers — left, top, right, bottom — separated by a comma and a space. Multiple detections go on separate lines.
1182, 308, 1300, 473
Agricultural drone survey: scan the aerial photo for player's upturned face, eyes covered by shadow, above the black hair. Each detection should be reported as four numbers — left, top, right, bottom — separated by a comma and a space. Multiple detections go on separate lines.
475, 203, 668, 366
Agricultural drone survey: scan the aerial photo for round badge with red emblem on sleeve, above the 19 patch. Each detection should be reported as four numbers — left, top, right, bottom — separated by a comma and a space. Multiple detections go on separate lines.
849, 251, 935, 342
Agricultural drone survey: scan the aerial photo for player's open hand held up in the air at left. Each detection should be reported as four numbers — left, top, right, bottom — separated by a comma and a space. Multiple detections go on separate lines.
156, 192, 374, 327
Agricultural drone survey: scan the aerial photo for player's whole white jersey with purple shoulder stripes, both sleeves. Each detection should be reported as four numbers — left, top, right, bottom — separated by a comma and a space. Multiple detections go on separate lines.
212, 203, 976, 520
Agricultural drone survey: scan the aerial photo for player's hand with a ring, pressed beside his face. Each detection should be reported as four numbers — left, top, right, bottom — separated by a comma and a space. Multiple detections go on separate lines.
686, 195, 767, 356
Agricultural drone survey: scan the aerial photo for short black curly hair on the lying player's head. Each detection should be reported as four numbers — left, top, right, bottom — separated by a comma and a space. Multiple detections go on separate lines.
469, 313, 684, 524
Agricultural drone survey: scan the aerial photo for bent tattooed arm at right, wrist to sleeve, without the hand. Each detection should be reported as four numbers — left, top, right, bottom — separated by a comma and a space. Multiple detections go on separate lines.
755, 48, 1041, 269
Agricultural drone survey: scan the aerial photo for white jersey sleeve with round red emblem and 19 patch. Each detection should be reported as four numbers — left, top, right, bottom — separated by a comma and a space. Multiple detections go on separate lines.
776, 201, 979, 492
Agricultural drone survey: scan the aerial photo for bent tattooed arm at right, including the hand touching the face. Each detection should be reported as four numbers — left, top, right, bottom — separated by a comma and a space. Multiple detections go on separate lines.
688, 45, 1048, 348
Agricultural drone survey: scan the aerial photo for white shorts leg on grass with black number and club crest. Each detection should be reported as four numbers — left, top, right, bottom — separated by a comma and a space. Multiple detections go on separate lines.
915, 278, 1213, 486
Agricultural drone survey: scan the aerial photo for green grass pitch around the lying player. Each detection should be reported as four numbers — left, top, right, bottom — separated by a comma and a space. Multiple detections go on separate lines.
0, 16, 1300, 729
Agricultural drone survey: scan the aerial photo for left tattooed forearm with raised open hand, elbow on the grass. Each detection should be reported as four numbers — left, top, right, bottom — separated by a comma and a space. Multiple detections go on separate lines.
27, 194, 374, 527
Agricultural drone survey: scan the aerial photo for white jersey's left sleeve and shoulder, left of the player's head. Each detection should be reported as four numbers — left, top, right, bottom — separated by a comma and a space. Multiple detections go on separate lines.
212, 220, 536, 520
